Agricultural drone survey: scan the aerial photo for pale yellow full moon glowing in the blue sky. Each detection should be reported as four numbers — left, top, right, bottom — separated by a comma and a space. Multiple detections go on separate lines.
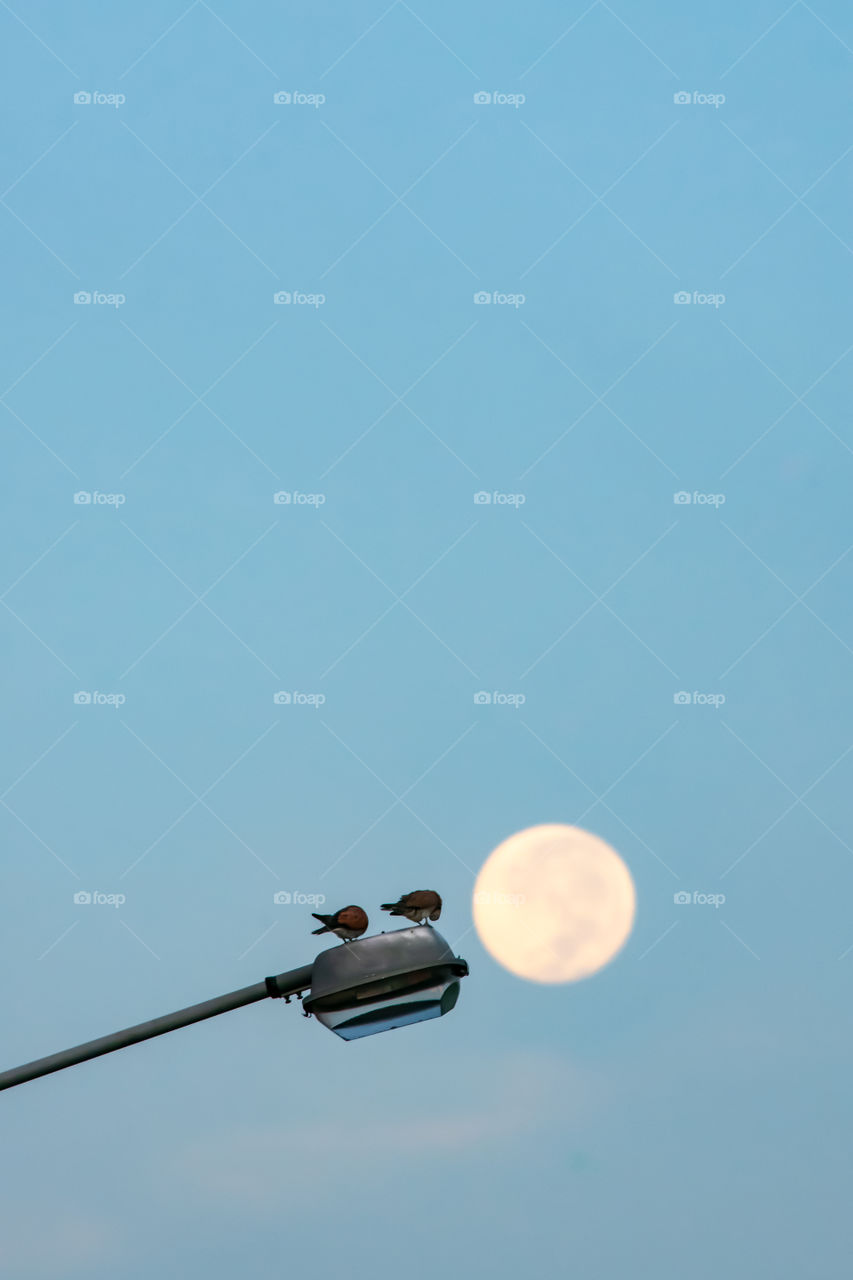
474, 823, 637, 982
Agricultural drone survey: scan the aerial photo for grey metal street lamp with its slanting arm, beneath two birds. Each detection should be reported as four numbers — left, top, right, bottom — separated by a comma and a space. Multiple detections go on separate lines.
0, 924, 467, 1089
